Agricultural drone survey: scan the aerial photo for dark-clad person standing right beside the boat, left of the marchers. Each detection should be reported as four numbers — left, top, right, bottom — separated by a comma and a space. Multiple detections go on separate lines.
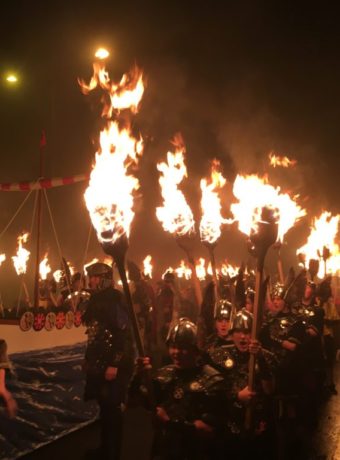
83, 262, 134, 460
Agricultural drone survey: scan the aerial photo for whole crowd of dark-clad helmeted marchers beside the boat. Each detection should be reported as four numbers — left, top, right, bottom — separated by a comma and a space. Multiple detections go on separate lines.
0, 262, 340, 460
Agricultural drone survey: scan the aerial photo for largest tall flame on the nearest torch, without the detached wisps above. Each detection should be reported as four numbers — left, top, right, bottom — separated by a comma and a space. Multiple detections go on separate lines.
84, 122, 143, 243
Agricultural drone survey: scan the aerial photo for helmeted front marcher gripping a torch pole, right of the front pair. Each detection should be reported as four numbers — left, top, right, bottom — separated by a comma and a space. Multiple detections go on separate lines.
210, 309, 276, 460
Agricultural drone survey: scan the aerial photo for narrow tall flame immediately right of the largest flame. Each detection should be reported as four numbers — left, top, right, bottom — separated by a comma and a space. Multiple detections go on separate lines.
156, 135, 195, 236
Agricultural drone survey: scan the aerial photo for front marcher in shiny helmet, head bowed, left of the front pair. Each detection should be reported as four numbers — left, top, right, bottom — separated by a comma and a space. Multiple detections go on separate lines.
130, 318, 226, 460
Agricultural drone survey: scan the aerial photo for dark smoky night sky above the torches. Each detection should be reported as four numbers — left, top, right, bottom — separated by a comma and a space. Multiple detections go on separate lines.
0, 0, 340, 300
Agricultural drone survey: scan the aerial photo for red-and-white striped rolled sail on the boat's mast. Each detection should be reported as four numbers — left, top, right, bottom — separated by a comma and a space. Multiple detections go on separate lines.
0, 174, 90, 192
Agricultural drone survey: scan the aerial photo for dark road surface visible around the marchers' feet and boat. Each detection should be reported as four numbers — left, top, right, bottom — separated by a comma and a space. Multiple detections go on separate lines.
22, 361, 340, 460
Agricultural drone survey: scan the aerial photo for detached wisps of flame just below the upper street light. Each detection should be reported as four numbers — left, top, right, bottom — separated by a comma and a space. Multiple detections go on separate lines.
78, 61, 144, 118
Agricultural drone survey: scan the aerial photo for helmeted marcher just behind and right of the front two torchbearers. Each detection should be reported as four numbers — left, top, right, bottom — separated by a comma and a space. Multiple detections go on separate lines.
260, 283, 305, 460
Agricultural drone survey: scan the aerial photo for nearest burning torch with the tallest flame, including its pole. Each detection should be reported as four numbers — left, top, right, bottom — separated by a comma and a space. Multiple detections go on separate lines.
80, 62, 144, 356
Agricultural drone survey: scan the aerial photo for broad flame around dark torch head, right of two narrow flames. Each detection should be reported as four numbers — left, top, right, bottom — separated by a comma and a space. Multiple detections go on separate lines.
230, 175, 306, 242
